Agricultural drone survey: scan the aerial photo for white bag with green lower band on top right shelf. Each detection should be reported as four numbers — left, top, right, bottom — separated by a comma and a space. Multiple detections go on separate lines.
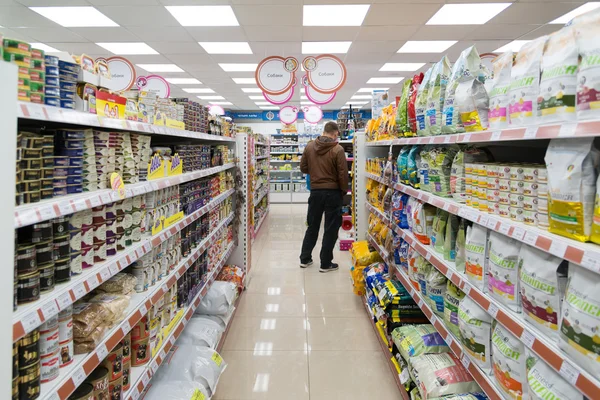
538, 25, 576, 123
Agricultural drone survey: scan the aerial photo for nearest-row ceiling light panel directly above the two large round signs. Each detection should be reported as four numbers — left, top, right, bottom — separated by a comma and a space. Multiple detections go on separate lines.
302, 4, 370, 26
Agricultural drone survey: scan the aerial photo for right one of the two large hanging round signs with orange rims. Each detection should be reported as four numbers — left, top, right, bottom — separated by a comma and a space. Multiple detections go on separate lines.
303, 54, 346, 94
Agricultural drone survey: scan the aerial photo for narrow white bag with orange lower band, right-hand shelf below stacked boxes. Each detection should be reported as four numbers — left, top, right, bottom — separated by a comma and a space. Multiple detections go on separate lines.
465, 224, 488, 292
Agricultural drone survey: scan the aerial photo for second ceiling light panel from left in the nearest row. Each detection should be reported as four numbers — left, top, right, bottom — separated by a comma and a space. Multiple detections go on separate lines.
165, 6, 240, 26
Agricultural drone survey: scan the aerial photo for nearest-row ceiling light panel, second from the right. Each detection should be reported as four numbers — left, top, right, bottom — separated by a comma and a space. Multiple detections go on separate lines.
426, 3, 512, 25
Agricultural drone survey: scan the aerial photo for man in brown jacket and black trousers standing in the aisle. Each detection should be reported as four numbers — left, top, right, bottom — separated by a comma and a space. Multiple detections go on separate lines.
300, 122, 348, 272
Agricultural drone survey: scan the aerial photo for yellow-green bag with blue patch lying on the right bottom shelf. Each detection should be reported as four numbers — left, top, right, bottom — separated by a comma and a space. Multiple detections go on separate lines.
392, 324, 450, 362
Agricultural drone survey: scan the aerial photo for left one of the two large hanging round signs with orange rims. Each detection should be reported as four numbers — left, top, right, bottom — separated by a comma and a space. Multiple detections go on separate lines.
255, 56, 298, 96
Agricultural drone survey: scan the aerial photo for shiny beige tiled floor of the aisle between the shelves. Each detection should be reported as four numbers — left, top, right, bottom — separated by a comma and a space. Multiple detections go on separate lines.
215, 205, 399, 400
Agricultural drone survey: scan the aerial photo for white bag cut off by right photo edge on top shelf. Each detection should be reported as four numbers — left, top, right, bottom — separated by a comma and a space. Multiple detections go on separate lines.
572, 9, 600, 119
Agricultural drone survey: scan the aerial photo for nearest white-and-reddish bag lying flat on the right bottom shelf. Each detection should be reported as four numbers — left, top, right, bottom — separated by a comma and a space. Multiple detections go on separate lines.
410, 353, 481, 400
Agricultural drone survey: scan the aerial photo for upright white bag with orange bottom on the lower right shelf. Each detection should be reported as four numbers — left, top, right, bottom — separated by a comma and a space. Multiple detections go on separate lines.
492, 321, 527, 400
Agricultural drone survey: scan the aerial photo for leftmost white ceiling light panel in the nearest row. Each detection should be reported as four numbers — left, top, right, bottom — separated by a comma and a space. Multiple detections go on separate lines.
29, 7, 119, 28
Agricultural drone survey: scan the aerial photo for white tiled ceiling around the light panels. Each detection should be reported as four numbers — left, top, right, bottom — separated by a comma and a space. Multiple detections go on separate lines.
0, 0, 584, 110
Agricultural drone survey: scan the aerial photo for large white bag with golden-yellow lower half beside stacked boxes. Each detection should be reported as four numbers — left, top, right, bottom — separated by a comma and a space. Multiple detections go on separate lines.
544, 138, 600, 242
